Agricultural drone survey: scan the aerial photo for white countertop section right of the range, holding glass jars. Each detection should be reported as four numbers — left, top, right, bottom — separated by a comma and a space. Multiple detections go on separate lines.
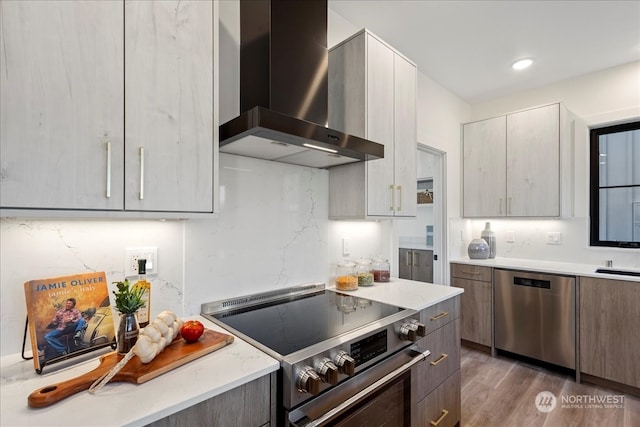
329, 277, 464, 310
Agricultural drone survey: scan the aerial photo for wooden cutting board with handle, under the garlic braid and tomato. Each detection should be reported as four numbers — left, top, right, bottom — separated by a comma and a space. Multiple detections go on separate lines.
27, 329, 233, 408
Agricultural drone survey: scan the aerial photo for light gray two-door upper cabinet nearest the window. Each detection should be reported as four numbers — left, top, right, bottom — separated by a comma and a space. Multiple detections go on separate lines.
463, 104, 573, 217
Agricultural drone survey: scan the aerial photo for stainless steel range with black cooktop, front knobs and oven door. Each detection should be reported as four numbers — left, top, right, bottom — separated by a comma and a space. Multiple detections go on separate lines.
202, 284, 430, 426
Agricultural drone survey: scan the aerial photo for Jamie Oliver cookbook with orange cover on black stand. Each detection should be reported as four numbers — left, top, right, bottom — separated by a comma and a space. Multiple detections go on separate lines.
24, 272, 116, 373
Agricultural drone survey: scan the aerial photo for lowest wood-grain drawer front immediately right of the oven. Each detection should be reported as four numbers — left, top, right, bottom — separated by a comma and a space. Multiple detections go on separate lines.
415, 370, 461, 427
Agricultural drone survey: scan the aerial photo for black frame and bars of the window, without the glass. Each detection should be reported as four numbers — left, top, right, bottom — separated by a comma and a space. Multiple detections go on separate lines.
589, 119, 640, 249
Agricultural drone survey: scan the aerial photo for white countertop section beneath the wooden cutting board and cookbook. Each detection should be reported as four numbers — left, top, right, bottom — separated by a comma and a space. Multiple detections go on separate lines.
0, 317, 280, 427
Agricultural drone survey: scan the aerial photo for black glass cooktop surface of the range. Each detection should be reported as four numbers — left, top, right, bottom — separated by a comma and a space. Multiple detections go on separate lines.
213, 291, 404, 356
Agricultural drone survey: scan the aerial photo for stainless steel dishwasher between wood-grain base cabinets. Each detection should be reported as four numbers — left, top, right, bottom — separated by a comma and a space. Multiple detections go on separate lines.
493, 269, 576, 370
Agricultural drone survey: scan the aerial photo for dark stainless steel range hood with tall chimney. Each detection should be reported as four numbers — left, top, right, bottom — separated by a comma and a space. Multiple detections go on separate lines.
220, 0, 384, 168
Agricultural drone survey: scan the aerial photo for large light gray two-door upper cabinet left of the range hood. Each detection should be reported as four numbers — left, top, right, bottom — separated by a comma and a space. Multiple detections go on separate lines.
0, 0, 217, 216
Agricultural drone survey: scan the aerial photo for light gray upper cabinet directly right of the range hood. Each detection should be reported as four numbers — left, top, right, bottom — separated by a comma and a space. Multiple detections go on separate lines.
329, 30, 417, 219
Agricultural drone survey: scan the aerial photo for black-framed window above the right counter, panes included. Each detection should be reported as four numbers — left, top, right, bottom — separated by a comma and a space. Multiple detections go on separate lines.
590, 121, 640, 248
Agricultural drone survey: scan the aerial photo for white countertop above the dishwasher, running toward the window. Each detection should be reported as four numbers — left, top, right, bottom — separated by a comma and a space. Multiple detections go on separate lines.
450, 257, 640, 282
